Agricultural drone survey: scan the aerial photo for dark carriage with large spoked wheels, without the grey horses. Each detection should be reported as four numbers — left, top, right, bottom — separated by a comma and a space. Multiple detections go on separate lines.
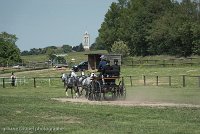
87, 64, 126, 100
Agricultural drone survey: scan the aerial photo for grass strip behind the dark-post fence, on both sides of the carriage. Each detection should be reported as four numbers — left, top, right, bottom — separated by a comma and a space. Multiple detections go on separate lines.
0, 66, 200, 88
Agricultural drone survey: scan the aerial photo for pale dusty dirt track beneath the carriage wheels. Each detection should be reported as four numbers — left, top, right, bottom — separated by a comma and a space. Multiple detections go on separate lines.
52, 98, 200, 108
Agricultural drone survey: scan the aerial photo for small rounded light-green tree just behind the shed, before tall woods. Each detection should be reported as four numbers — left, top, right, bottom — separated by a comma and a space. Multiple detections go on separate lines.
111, 41, 130, 57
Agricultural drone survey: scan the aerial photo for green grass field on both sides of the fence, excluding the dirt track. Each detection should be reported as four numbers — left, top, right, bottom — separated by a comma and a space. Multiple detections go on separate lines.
0, 66, 200, 134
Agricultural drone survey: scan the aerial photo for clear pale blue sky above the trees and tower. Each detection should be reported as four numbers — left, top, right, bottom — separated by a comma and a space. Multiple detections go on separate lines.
0, 0, 117, 51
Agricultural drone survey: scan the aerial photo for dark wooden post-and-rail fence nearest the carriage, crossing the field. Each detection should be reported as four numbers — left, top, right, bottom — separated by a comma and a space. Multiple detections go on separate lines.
0, 75, 200, 88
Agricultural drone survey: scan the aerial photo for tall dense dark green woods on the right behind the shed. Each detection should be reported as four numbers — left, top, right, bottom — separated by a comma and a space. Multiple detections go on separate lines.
93, 0, 200, 57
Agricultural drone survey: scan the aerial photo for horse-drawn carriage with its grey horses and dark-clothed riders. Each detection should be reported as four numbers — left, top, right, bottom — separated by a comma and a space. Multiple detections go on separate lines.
61, 59, 126, 101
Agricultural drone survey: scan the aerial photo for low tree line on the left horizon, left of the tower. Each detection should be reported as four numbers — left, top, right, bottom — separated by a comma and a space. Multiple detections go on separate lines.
0, 32, 85, 67
